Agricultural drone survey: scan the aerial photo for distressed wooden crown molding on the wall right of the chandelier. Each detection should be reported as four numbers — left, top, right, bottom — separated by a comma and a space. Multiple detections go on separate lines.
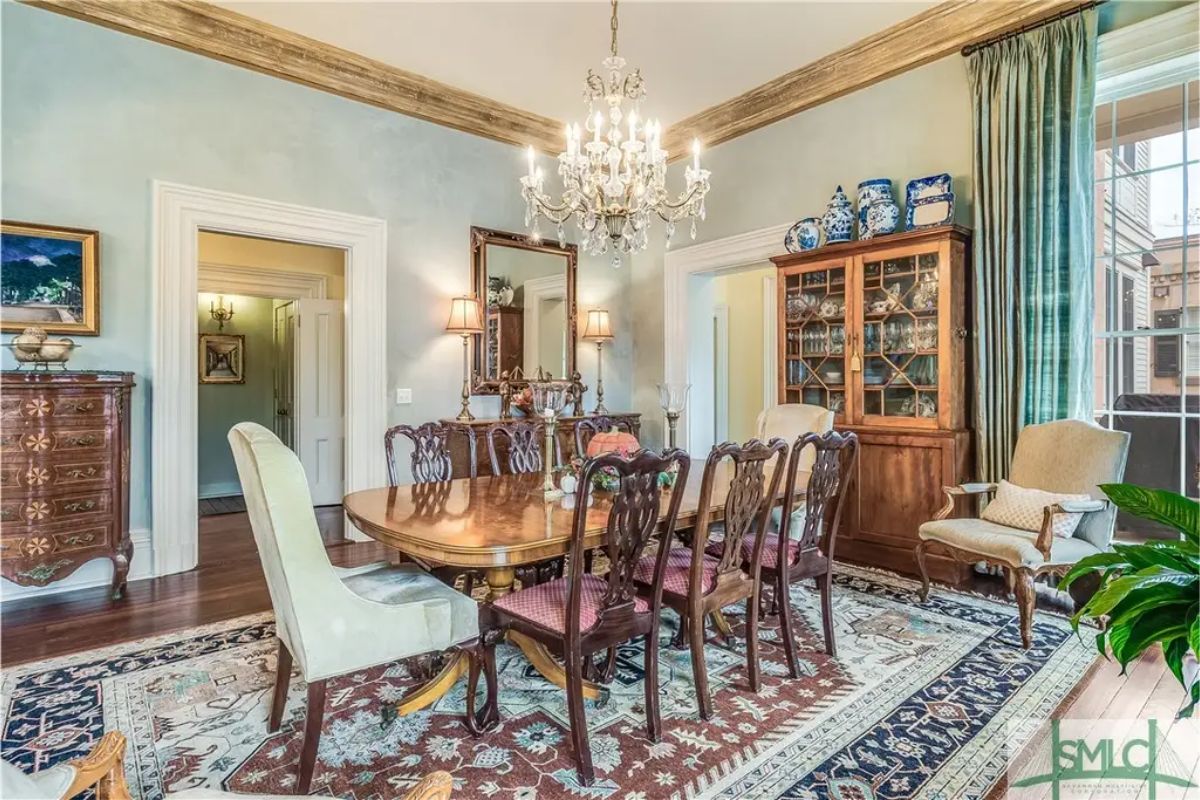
664, 0, 1086, 158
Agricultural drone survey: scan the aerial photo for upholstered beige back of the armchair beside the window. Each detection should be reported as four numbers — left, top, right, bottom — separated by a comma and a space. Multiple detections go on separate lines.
1008, 420, 1129, 551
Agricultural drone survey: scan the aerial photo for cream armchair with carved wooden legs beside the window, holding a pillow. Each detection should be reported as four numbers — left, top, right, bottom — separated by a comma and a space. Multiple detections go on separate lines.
917, 420, 1129, 648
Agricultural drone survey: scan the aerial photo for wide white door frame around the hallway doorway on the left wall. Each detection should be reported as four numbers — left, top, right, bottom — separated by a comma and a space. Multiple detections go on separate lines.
150, 181, 388, 575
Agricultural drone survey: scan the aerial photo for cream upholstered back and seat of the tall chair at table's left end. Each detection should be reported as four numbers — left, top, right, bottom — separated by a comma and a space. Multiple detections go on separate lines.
229, 422, 478, 681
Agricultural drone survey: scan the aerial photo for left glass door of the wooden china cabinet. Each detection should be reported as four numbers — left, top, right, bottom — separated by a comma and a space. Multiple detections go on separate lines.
781, 263, 847, 421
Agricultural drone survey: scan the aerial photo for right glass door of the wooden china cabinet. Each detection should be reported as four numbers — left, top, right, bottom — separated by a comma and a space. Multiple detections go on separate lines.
859, 249, 942, 427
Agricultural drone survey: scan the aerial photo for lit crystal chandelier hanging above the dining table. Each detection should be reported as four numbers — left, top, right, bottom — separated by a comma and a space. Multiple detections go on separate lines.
521, 0, 709, 266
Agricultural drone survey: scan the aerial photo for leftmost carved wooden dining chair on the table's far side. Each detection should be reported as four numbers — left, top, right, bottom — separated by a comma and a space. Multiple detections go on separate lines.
383, 422, 481, 596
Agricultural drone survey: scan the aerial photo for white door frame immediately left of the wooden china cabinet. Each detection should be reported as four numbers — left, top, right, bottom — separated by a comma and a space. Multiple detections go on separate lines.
662, 223, 792, 452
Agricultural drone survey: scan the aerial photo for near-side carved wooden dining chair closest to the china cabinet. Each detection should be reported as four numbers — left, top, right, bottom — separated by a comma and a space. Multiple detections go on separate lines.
761, 431, 858, 678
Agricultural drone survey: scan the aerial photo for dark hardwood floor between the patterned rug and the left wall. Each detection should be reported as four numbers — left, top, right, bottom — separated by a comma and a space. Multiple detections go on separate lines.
0, 506, 388, 667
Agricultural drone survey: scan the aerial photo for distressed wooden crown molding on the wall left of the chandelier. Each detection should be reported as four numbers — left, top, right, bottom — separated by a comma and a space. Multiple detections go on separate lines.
25, 0, 564, 152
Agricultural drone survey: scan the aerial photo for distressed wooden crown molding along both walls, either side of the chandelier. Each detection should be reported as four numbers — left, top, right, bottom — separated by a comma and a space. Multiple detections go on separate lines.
30, 0, 1086, 158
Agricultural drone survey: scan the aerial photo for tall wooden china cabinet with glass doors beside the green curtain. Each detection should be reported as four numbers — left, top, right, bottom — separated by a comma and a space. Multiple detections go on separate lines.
772, 225, 971, 582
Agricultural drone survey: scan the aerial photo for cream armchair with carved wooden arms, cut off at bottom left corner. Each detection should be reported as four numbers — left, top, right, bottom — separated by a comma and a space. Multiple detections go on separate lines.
0, 730, 454, 800
